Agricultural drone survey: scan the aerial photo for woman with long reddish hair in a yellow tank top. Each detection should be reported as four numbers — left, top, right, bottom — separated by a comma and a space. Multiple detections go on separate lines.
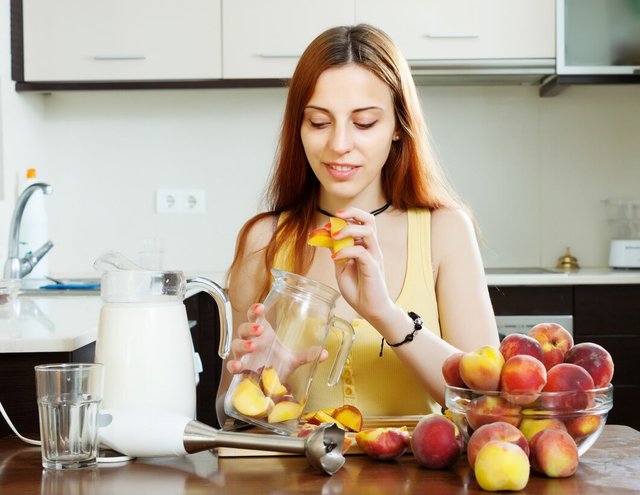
220, 25, 498, 416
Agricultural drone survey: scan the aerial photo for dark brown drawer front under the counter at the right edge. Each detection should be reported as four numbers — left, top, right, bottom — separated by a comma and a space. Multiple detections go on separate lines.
573, 285, 640, 336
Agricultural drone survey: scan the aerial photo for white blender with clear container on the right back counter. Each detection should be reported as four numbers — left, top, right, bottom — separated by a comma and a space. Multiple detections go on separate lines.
604, 199, 640, 269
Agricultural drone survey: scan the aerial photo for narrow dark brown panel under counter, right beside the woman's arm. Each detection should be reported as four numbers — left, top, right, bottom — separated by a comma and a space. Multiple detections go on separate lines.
489, 285, 573, 316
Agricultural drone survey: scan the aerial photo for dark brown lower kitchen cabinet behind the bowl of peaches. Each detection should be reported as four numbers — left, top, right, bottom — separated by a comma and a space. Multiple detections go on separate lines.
489, 284, 640, 428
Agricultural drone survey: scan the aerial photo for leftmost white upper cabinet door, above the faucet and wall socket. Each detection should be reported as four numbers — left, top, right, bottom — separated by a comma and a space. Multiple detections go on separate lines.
23, 0, 222, 81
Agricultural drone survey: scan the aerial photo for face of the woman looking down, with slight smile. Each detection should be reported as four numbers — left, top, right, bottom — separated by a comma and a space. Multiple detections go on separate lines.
300, 64, 396, 208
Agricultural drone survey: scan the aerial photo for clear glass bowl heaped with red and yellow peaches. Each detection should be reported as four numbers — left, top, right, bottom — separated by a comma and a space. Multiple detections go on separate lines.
442, 326, 613, 455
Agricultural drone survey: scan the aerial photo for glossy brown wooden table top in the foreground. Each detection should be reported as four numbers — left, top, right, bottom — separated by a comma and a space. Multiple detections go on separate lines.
0, 425, 640, 495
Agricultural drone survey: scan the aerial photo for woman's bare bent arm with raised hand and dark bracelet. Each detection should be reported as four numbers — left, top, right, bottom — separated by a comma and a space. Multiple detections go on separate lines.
336, 209, 499, 404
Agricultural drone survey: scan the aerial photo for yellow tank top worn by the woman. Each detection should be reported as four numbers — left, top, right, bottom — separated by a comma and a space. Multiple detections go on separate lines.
274, 210, 441, 416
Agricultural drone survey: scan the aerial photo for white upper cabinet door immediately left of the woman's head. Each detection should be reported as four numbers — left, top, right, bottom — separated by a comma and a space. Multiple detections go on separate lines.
222, 0, 355, 79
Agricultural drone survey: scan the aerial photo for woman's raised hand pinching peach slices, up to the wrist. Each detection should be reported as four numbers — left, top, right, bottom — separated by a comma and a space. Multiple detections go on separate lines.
332, 208, 394, 322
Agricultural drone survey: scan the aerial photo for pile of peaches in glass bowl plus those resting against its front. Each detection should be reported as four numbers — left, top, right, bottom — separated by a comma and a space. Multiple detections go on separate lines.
442, 323, 614, 490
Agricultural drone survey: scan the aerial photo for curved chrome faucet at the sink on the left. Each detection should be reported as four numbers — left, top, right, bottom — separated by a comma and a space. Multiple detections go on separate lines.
4, 182, 53, 278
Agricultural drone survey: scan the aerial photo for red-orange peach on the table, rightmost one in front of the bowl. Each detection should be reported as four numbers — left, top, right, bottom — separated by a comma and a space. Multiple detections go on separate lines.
529, 430, 579, 478
